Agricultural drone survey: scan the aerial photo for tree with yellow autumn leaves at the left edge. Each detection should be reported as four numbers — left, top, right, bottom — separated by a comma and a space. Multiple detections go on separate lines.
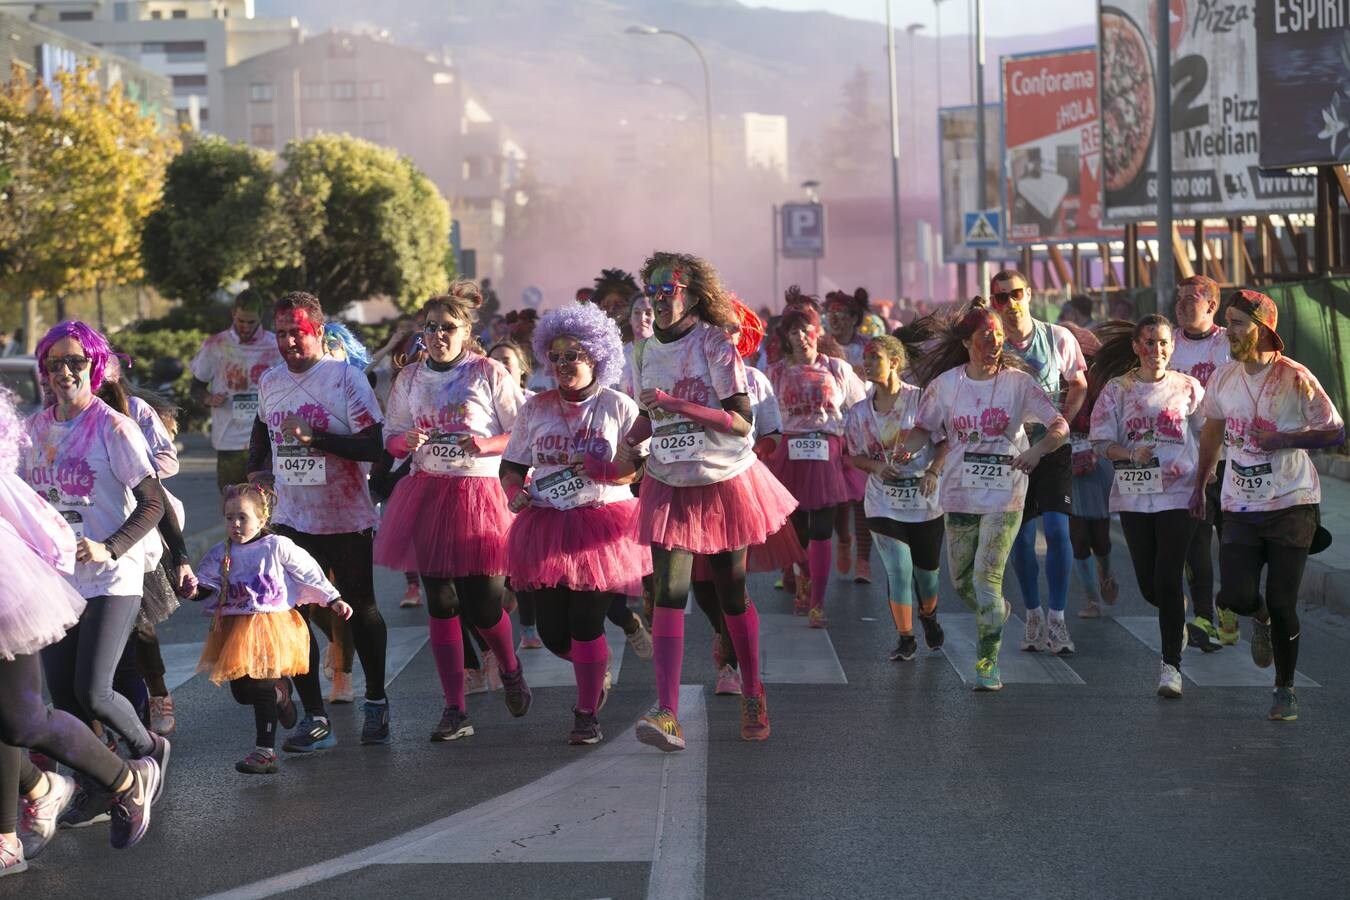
0, 65, 177, 347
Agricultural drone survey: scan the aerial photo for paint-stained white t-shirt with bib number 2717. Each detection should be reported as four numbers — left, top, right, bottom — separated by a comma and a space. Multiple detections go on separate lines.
844, 383, 942, 522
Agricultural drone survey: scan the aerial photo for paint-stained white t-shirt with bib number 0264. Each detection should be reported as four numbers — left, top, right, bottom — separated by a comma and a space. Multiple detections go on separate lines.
385, 351, 525, 478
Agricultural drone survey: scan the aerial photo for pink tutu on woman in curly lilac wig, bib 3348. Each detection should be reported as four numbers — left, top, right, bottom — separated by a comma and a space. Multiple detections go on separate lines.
506, 499, 652, 596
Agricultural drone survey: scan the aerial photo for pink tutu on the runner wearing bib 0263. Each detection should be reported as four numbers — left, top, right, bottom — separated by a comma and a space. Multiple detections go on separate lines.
637, 460, 797, 553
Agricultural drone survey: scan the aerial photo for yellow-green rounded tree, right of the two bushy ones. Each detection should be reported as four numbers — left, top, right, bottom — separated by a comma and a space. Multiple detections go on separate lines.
281, 135, 450, 312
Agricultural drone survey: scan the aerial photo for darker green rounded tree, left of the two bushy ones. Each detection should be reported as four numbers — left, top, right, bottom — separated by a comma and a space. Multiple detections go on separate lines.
140, 138, 300, 309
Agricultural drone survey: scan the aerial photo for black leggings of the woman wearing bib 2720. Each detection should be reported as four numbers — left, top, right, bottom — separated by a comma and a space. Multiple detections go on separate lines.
1121, 510, 1195, 668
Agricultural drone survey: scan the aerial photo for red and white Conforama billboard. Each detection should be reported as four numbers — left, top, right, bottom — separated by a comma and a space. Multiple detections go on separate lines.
1002, 47, 1121, 244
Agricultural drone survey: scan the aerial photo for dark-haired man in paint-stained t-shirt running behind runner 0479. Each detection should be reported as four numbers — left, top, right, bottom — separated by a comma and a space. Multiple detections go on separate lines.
188, 289, 281, 491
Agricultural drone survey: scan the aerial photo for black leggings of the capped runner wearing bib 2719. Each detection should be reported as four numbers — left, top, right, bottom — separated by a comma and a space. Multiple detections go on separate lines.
1219, 541, 1308, 687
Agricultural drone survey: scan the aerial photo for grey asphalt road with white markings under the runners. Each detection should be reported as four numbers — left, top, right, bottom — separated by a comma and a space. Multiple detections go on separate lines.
10, 437, 1350, 899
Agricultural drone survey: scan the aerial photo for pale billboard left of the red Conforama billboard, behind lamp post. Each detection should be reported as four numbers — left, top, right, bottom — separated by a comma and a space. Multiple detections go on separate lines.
937, 103, 1003, 263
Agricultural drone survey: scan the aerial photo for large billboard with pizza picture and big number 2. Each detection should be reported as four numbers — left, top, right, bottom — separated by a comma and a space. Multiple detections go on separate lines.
1098, 0, 1314, 223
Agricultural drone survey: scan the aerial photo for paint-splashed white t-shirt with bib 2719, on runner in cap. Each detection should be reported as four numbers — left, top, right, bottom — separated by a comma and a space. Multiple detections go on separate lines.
1200, 355, 1345, 513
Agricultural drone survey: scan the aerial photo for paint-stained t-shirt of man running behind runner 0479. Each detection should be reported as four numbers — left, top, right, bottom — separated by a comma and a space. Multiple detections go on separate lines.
188, 328, 281, 451
